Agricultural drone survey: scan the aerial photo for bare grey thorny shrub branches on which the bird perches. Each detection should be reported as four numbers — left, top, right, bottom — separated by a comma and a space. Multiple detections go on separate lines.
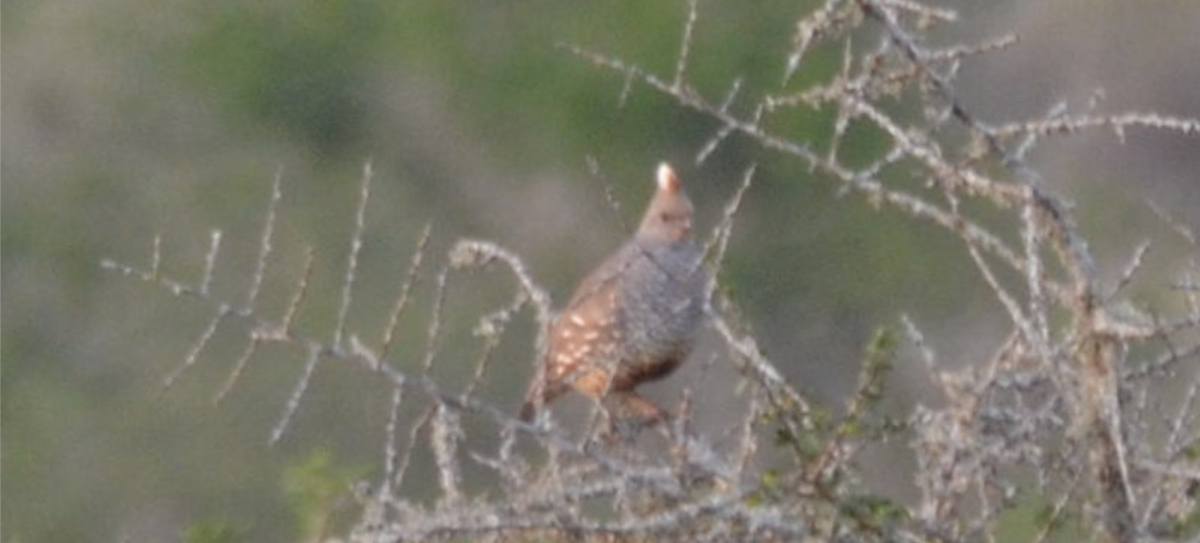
103, 0, 1200, 542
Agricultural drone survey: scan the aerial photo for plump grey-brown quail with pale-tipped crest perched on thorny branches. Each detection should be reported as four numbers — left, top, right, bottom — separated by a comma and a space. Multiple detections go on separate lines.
520, 163, 709, 422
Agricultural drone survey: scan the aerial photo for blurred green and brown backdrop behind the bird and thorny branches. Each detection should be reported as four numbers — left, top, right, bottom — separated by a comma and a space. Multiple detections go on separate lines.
0, 0, 1200, 542
